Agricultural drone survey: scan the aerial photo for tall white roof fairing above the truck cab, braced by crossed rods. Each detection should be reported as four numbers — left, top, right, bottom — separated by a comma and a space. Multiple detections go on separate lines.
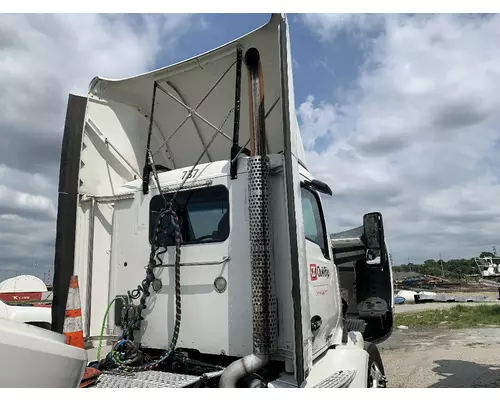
83, 14, 307, 170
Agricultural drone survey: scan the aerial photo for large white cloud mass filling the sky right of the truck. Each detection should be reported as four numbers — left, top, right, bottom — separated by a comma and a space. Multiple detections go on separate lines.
299, 14, 500, 262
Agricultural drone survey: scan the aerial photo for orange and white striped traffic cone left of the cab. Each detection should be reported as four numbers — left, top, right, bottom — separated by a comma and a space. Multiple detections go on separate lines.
63, 275, 85, 349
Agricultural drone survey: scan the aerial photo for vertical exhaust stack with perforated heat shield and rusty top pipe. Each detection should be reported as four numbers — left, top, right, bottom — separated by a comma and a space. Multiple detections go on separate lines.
219, 48, 277, 387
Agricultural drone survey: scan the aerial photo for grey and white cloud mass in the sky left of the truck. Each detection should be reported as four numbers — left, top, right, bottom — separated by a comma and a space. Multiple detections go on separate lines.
0, 14, 197, 278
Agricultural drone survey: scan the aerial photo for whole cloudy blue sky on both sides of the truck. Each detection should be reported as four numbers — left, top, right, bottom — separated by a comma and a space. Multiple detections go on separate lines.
0, 14, 500, 279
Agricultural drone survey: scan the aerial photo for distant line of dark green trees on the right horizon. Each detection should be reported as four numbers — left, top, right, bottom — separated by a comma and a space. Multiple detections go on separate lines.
393, 251, 497, 280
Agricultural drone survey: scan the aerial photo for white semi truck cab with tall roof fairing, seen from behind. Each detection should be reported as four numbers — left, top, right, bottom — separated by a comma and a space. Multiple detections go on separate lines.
52, 14, 392, 388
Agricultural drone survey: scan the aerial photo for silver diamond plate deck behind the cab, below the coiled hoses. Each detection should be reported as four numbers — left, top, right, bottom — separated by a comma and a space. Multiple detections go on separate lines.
95, 371, 200, 388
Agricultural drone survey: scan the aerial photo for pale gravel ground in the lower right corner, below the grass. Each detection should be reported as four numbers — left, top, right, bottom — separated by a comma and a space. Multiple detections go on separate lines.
378, 328, 500, 388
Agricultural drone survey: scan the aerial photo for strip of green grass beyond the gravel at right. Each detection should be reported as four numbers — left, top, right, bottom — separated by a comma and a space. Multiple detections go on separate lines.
394, 304, 500, 329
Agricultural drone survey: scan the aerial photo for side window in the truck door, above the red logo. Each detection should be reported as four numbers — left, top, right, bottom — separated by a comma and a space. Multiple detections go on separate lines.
301, 187, 330, 259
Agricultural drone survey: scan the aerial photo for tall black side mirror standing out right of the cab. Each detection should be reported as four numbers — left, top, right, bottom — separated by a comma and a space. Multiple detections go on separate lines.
363, 212, 385, 265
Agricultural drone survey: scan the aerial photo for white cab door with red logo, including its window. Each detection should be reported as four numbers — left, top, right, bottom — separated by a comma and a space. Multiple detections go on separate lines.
301, 186, 341, 356
